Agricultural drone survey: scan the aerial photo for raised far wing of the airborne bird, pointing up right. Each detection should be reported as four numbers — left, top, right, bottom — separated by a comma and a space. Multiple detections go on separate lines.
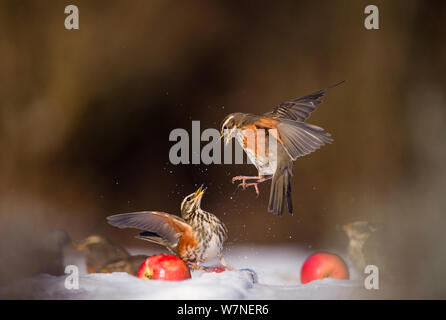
265, 81, 345, 122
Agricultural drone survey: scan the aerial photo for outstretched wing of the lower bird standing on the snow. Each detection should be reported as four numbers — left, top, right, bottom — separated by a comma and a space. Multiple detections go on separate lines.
107, 211, 192, 248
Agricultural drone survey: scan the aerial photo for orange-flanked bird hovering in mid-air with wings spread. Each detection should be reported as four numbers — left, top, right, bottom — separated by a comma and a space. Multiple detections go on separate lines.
221, 81, 344, 215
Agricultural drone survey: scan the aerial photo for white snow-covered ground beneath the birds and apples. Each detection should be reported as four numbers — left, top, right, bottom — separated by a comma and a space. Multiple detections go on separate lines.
0, 246, 392, 299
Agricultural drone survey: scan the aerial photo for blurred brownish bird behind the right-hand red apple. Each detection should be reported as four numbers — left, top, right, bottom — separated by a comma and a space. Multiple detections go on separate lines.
342, 221, 378, 274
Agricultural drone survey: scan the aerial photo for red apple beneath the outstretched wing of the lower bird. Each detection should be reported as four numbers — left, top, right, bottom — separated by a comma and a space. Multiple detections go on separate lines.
136, 254, 191, 281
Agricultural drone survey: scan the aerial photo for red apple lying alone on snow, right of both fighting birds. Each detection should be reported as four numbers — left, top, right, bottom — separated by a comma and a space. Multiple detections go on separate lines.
300, 252, 349, 283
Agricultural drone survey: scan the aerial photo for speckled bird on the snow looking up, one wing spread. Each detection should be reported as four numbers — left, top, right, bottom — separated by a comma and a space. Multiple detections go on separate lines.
107, 186, 232, 270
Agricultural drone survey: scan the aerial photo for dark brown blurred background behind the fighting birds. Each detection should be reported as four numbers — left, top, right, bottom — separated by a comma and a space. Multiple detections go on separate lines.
0, 0, 446, 298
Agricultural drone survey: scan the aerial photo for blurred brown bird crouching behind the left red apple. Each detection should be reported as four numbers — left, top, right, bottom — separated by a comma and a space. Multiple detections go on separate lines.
74, 235, 130, 273
